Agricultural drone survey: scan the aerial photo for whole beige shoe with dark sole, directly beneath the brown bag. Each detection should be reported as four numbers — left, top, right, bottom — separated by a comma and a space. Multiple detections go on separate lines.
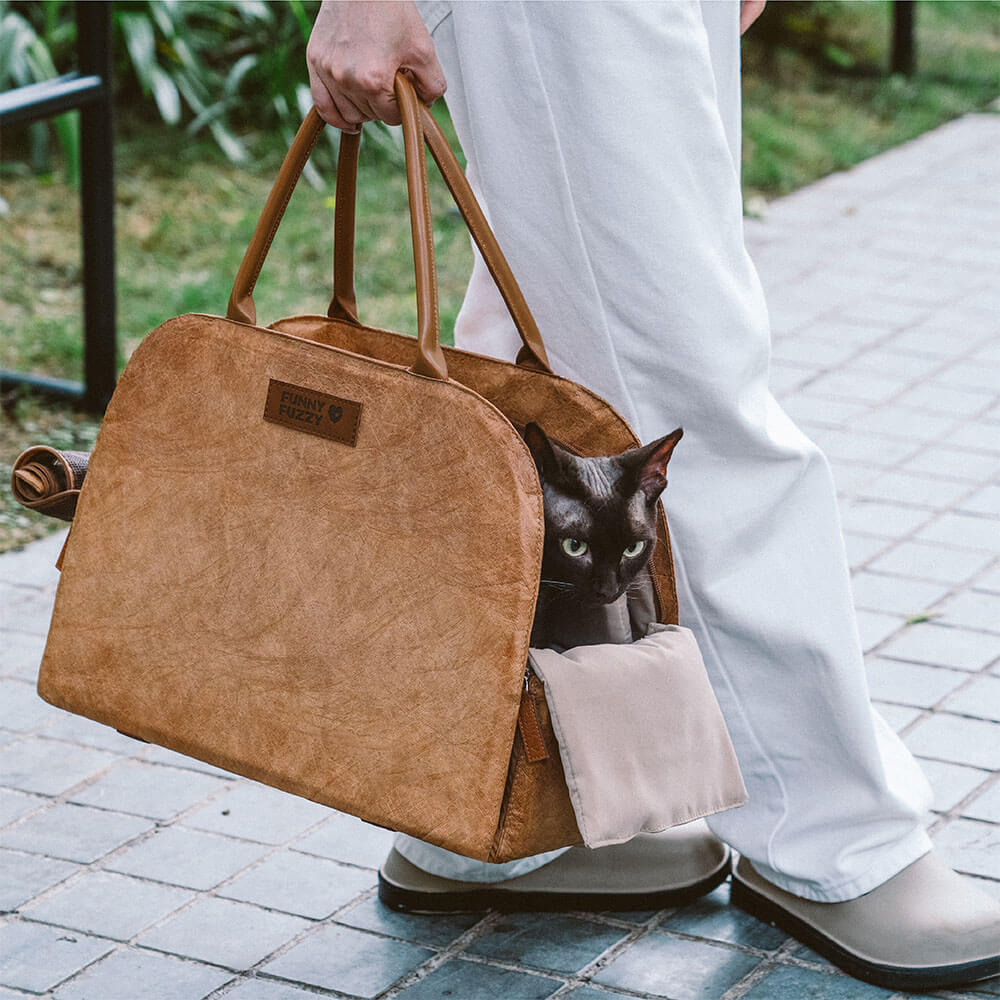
378, 823, 731, 913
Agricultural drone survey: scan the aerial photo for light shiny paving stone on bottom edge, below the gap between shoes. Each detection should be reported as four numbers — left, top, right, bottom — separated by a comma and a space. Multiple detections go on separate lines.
594, 932, 761, 1000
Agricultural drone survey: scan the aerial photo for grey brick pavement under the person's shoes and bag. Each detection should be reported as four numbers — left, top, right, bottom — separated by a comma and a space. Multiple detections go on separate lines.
0, 115, 1000, 1000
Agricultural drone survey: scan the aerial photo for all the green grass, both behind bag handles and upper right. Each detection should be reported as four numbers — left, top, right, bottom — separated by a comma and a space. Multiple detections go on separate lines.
0, 0, 1000, 551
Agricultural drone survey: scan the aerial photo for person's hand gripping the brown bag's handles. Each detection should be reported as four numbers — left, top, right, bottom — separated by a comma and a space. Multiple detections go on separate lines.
306, 0, 446, 132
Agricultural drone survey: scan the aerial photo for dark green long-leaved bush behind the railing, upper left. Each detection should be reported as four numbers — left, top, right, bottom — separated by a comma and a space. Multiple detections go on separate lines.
0, 0, 402, 174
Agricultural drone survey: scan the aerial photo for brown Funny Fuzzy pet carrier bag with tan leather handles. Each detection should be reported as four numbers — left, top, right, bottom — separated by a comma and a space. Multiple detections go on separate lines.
38, 77, 742, 861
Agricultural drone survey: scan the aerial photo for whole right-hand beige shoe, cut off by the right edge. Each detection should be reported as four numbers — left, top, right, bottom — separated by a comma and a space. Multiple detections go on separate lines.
732, 853, 1000, 990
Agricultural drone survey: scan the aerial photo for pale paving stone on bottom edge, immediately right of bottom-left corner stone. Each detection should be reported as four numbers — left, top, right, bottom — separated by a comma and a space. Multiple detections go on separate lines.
54, 948, 233, 1000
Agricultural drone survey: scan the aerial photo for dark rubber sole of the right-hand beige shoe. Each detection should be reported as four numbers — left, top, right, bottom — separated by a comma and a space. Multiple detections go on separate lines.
730, 874, 1000, 990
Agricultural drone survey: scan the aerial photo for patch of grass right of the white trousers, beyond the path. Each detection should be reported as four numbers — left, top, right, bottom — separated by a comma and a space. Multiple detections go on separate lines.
743, 0, 1000, 201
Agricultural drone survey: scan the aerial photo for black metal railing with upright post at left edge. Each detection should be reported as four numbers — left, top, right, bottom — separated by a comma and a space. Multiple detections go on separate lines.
0, 0, 118, 413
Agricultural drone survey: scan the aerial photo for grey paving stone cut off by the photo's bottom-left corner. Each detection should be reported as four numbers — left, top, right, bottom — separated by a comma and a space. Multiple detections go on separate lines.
0, 920, 114, 993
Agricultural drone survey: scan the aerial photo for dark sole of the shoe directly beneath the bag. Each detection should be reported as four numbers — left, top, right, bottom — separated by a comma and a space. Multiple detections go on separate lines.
378, 853, 732, 913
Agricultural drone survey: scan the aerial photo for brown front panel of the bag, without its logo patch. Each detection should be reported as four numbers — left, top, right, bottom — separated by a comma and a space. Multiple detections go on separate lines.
39, 316, 544, 857
